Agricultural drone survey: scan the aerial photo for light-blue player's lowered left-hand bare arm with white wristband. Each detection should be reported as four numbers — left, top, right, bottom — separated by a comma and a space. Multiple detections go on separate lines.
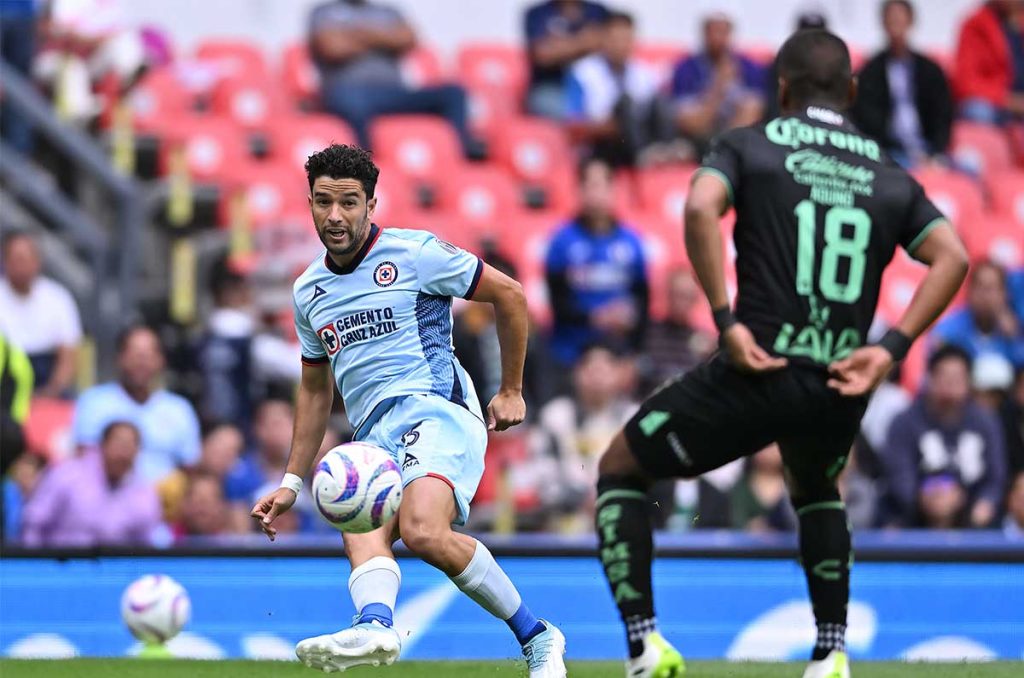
250, 363, 334, 541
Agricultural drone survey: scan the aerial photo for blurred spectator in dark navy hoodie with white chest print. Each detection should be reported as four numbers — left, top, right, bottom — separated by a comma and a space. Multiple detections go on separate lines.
882, 346, 1007, 527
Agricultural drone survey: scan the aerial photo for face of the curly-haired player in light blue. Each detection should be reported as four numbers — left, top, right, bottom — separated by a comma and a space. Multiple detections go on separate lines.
309, 176, 377, 257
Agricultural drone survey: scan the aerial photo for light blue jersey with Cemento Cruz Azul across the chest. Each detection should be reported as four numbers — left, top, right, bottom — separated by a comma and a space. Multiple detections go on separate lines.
294, 224, 483, 439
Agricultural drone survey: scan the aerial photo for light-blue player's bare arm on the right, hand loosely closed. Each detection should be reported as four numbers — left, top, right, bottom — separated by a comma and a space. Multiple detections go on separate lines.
473, 264, 529, 431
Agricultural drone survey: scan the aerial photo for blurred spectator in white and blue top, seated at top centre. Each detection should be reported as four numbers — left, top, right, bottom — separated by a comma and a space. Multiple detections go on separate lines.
565, 12, 663, 167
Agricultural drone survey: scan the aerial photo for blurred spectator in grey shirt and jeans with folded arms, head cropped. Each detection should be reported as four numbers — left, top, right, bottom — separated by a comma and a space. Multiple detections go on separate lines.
309, 0, 480, 157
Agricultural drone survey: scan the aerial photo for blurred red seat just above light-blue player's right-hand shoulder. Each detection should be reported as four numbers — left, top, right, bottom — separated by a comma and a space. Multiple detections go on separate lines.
437, 167, 520, 232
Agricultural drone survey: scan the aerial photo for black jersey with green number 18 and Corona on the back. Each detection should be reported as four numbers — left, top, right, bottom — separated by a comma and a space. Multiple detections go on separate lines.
698, 107, 944, 366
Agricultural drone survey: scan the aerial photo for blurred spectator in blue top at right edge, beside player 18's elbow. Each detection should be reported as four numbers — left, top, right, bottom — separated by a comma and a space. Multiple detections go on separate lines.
932, 261, 1024, 368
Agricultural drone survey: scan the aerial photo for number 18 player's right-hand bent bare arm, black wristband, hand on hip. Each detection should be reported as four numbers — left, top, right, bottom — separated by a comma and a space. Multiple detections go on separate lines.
828, 223, 968, 396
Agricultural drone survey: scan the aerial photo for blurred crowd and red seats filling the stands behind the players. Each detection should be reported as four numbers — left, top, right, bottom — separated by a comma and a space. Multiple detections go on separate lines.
6, 0, 1024, 547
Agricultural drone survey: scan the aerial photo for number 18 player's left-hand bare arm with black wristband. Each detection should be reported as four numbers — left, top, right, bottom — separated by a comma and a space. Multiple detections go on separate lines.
685, 174, 786, 372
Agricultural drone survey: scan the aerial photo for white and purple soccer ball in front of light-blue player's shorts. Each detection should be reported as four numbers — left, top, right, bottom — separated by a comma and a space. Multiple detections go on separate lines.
313, 442, 401, 534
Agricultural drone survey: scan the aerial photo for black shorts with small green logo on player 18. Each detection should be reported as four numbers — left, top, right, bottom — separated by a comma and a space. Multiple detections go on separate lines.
626, 354, 867, 494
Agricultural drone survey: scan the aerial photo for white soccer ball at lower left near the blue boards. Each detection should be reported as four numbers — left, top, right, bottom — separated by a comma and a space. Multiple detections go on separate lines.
121, 575, 191, 644
